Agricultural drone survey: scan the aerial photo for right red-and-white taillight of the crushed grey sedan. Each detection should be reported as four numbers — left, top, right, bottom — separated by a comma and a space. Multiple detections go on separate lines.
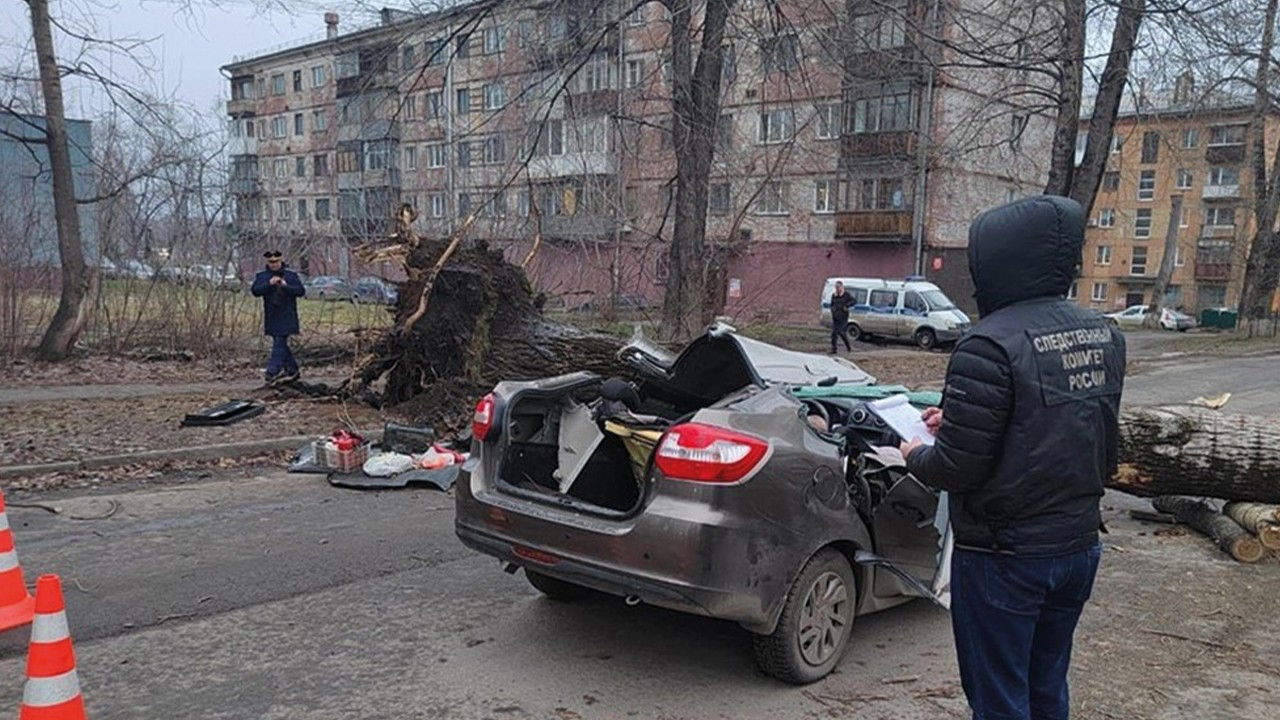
654, 423, 769, 483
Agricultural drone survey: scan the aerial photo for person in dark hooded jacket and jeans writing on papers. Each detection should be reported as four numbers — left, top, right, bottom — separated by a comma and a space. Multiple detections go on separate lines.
902, 196, 1125, 720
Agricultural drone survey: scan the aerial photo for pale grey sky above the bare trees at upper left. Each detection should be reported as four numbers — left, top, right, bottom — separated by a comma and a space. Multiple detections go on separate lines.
0, 0, 386, 117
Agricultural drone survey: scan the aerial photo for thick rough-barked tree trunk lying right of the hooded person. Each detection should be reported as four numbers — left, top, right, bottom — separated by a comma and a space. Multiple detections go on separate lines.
1108, 407, 1280, 503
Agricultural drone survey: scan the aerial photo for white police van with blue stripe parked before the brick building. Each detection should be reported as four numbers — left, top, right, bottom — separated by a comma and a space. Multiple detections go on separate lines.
818, 278, 969, 350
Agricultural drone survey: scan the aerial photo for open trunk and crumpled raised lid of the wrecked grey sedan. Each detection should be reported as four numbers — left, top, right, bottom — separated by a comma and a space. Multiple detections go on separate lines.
498, 329, 874, 515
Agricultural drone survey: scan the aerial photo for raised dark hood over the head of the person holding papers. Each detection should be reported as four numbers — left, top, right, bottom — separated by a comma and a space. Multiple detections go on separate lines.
969, 195, 1084, 315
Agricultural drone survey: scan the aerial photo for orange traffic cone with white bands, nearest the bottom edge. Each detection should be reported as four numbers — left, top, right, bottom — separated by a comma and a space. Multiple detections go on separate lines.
18, 575, 86, 720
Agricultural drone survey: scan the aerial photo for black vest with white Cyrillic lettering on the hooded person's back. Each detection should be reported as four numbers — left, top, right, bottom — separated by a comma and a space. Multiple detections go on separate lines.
951, 297, 1125, 555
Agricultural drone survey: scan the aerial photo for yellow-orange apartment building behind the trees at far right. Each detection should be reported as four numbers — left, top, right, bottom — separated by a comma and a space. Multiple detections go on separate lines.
1073, 90, 1280, 313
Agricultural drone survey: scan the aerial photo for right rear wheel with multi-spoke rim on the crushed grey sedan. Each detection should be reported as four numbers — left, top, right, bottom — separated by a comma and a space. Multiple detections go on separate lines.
753, 547, 858, 685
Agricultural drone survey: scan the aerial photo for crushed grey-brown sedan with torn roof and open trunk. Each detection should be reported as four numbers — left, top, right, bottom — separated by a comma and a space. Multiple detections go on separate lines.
456, 325, 950, 683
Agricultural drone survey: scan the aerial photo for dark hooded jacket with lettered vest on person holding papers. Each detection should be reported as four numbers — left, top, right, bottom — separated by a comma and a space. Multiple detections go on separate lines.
908, 196, 1125, 556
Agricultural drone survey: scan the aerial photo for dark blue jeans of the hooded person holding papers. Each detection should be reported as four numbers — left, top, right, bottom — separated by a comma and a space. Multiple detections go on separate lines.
951, 544, 1102, 720
